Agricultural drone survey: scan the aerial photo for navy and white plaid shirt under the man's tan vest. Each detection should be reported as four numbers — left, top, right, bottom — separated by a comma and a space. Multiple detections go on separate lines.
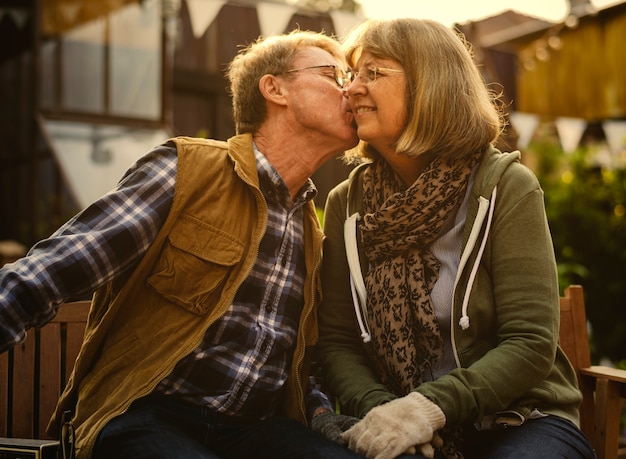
0, 143, 328, 418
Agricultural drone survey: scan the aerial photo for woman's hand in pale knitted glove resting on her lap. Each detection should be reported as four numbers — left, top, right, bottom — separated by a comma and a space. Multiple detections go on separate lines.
341, 392, 446, 459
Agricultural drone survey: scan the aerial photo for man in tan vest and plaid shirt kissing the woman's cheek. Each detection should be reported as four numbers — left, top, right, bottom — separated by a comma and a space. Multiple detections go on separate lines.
0, 31, 361, 459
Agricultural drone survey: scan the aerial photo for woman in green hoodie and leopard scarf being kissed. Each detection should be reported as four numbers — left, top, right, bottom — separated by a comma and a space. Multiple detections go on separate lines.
319, 19, 594, 459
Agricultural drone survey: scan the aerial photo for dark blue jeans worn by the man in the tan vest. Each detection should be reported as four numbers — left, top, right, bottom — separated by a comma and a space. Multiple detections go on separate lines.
93, 397, 363, 459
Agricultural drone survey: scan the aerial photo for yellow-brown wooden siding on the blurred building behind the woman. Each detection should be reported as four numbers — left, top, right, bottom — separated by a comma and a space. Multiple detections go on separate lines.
516, 4, 626, 120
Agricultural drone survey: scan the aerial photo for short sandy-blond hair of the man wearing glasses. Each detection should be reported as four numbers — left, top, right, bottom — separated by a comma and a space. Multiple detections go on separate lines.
226, 29, 344, 134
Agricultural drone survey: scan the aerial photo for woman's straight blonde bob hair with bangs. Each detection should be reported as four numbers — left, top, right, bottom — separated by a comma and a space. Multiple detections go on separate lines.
343, 18, 503, 162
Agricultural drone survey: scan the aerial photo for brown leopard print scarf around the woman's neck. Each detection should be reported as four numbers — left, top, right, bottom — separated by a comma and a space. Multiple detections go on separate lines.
361, 153, 480, 396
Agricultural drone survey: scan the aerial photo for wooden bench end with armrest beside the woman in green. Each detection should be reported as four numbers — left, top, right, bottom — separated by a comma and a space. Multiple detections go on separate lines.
559, 285, 626, 459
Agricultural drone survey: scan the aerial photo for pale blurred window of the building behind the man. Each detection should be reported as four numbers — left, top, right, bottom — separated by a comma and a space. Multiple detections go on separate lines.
40, 0, 163, 121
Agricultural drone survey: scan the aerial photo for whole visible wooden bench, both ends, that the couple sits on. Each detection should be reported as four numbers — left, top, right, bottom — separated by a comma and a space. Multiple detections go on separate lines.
0, 285, 626, 459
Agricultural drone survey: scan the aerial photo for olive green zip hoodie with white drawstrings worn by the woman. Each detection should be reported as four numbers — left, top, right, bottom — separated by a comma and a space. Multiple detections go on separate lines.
318, 147, 582, 432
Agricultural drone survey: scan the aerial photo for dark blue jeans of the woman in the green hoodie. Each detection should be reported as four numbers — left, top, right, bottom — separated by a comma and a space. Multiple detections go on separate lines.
398, 416, 596, 459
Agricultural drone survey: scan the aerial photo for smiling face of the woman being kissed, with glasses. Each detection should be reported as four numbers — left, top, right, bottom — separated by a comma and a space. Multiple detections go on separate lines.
348, 52, 408, 154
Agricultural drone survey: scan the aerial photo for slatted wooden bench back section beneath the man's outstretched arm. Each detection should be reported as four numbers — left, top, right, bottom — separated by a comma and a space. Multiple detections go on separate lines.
0, 301, 91, 439
